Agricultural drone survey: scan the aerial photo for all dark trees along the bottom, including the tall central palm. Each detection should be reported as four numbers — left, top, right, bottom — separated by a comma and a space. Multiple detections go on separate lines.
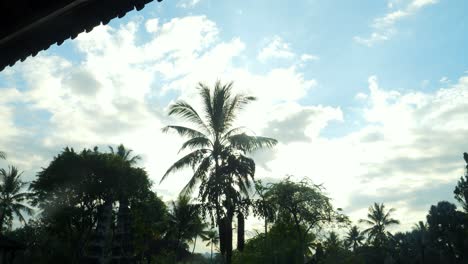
0, 83, 468, 264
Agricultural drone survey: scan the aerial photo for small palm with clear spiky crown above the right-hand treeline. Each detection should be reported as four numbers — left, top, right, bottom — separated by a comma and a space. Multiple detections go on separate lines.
359, 203, 400, 247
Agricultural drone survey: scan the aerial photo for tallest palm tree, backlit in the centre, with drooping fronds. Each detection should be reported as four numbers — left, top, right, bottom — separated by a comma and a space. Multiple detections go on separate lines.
161, 81, 277, 263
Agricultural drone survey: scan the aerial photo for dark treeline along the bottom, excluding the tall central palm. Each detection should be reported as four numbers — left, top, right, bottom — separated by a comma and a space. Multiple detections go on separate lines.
0, 150, 468, 264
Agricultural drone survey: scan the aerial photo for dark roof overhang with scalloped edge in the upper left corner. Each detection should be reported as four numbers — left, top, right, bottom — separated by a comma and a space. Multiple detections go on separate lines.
0, 0, 162, 71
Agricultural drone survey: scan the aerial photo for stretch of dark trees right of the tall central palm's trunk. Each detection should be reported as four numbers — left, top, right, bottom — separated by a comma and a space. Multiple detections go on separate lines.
234, 159, 468, 264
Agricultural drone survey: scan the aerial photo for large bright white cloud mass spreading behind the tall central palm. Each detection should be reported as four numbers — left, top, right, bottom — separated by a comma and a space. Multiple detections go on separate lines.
0, 11, 468, 233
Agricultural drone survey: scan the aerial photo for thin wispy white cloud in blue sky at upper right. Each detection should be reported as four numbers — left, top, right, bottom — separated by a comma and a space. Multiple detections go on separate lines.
353, 0, 437, 47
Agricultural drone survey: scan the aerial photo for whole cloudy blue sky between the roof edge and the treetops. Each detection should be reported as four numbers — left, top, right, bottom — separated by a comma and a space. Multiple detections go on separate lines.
0, 0, 468, 237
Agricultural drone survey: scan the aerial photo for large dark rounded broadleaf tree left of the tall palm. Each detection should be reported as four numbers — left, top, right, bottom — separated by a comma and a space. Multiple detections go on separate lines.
30, 148, 150, 262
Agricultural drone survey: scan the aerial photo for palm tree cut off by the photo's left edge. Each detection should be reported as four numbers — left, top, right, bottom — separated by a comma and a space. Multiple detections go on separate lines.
0, 166, 33, 233
